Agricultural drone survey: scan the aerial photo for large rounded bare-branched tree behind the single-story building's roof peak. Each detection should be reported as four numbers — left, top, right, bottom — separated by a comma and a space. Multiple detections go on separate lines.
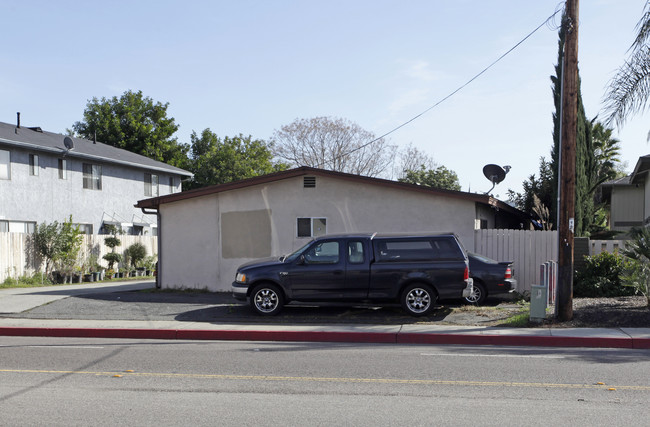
272, 117, 397, 176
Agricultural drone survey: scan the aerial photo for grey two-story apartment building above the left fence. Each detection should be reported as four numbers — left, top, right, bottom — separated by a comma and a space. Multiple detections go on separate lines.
0, 118, 192, 236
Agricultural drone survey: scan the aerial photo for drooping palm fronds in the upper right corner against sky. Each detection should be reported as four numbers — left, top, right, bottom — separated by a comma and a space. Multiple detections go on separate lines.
604, 0, 650, 127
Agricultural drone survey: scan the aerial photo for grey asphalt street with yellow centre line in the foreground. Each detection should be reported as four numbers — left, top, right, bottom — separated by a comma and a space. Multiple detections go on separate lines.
0, 337, 650, 426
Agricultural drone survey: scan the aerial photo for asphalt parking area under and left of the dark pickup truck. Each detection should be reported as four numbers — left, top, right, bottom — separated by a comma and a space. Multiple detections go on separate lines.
0, 283, 507, 325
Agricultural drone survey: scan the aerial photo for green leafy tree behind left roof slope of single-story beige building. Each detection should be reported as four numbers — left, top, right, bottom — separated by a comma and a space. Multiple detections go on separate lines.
184, 129, 288, 189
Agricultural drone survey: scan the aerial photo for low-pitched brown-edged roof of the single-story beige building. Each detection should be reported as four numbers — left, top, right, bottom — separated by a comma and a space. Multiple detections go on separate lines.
135, 166, 530, 218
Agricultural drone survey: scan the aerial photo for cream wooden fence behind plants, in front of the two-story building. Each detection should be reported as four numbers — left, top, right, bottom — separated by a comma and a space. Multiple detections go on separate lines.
0, 233, 158, 282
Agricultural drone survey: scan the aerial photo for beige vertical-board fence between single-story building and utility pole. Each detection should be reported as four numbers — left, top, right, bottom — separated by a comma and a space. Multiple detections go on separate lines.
474, 230, 558, 293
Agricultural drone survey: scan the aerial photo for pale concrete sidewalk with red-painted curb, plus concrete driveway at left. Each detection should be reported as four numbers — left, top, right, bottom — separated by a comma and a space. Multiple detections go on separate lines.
0, 281, 650, 349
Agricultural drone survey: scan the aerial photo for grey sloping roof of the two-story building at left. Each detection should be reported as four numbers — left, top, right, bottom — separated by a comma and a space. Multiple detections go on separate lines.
0, 122, 192, 177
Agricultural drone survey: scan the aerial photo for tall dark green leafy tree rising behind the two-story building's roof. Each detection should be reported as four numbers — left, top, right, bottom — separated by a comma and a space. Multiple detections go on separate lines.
72, 90, 187, 167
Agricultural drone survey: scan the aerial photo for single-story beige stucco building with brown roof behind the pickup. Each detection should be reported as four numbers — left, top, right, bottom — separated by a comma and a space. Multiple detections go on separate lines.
136, 167, 529, 291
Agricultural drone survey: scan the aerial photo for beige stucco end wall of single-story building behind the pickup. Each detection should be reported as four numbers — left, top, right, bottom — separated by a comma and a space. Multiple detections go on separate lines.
160, 176, 476, 291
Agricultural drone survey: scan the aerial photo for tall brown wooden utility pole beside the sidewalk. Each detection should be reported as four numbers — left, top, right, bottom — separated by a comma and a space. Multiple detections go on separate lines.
557, 0, 578, 321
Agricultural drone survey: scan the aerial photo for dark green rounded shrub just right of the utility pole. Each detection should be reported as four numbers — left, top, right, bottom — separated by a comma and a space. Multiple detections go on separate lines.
573, 252, 635, 298
